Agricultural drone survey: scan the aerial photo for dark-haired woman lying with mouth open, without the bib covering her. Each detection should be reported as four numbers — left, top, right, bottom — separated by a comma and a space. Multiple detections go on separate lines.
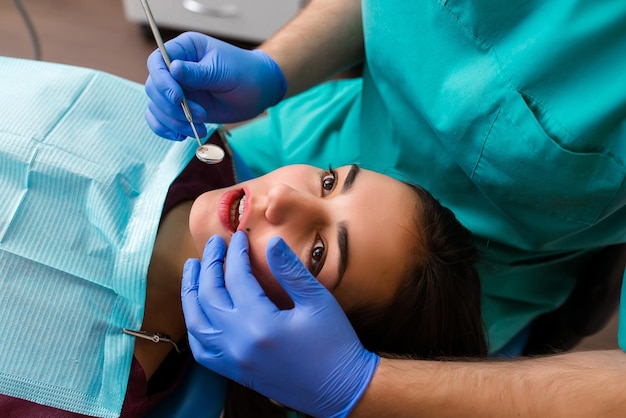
0, 131, 486, 416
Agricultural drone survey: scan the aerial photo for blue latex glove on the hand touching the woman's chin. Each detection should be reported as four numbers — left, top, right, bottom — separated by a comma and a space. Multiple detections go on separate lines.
182, 232, 379, 417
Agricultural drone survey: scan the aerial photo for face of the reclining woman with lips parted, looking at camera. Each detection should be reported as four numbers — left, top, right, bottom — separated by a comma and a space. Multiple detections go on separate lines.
189, 165, 419, 312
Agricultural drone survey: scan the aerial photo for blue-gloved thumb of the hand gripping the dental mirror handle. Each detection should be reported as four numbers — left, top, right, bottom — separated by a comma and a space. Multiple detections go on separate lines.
170, 60, 232, 92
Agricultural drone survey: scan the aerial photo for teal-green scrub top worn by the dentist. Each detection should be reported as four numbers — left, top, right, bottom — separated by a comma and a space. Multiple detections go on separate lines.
232, 0, 626, 351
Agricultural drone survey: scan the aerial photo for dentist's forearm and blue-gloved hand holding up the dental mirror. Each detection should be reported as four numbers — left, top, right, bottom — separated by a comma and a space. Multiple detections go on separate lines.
145, 0, 364, 140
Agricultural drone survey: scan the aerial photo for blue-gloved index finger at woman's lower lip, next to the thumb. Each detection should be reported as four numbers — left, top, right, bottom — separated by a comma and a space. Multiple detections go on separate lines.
221, 231, 278, 312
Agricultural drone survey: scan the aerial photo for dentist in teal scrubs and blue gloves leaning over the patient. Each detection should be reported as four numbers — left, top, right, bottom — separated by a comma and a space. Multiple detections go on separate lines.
146, 0, 626, 417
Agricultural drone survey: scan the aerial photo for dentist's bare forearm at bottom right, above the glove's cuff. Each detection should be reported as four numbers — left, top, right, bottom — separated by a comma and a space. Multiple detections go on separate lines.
350, 350, 626, 418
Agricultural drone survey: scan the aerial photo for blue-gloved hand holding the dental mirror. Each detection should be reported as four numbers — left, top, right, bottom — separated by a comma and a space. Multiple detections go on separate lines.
145, 32, 287, 140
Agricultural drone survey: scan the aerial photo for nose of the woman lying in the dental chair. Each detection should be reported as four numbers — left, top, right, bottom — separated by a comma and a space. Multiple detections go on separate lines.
265, 184, 320, 225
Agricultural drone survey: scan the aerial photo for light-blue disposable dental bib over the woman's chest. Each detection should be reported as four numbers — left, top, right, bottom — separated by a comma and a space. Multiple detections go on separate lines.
0, 58, 211, 417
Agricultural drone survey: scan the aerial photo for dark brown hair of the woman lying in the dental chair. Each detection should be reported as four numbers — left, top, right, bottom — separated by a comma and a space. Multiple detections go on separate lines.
225, 186, 487, 418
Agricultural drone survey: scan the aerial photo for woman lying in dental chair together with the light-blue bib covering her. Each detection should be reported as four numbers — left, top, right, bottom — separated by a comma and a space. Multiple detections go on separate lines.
0, 56, 486, 417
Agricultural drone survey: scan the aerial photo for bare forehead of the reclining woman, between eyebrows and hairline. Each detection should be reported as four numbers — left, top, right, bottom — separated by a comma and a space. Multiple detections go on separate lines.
335, 171, 421, 309
